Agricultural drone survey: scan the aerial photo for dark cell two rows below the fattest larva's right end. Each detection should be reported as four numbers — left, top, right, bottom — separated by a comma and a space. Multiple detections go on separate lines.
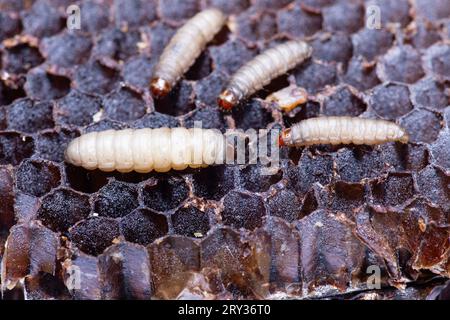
221, 191, 266, 230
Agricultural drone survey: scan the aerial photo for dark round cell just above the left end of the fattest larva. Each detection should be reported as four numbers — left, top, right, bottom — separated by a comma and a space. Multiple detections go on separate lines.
55, 90, 101, 126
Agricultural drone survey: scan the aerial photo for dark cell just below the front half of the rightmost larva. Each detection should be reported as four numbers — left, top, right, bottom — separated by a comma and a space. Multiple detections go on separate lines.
287, 152, 333, 195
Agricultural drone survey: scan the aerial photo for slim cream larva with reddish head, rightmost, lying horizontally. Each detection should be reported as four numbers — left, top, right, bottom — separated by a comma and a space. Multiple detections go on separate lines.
280, 117, 409, 147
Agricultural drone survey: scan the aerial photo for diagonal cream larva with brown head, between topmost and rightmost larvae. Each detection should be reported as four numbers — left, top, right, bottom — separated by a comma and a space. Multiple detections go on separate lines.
217, 41, 312, 110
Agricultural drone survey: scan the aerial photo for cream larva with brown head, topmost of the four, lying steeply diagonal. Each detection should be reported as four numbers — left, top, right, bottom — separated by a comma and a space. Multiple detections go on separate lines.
150, 9, 226, 97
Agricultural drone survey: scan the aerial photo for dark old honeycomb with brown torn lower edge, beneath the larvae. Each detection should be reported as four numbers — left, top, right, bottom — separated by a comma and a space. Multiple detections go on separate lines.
0, 0, 450, 299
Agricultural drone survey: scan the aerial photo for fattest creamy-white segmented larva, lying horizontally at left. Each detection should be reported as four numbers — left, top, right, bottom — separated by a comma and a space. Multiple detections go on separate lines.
65, 128, 225, 172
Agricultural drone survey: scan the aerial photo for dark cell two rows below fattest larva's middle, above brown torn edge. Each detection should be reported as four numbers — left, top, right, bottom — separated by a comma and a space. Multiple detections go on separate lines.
120, 209, 169, 245
